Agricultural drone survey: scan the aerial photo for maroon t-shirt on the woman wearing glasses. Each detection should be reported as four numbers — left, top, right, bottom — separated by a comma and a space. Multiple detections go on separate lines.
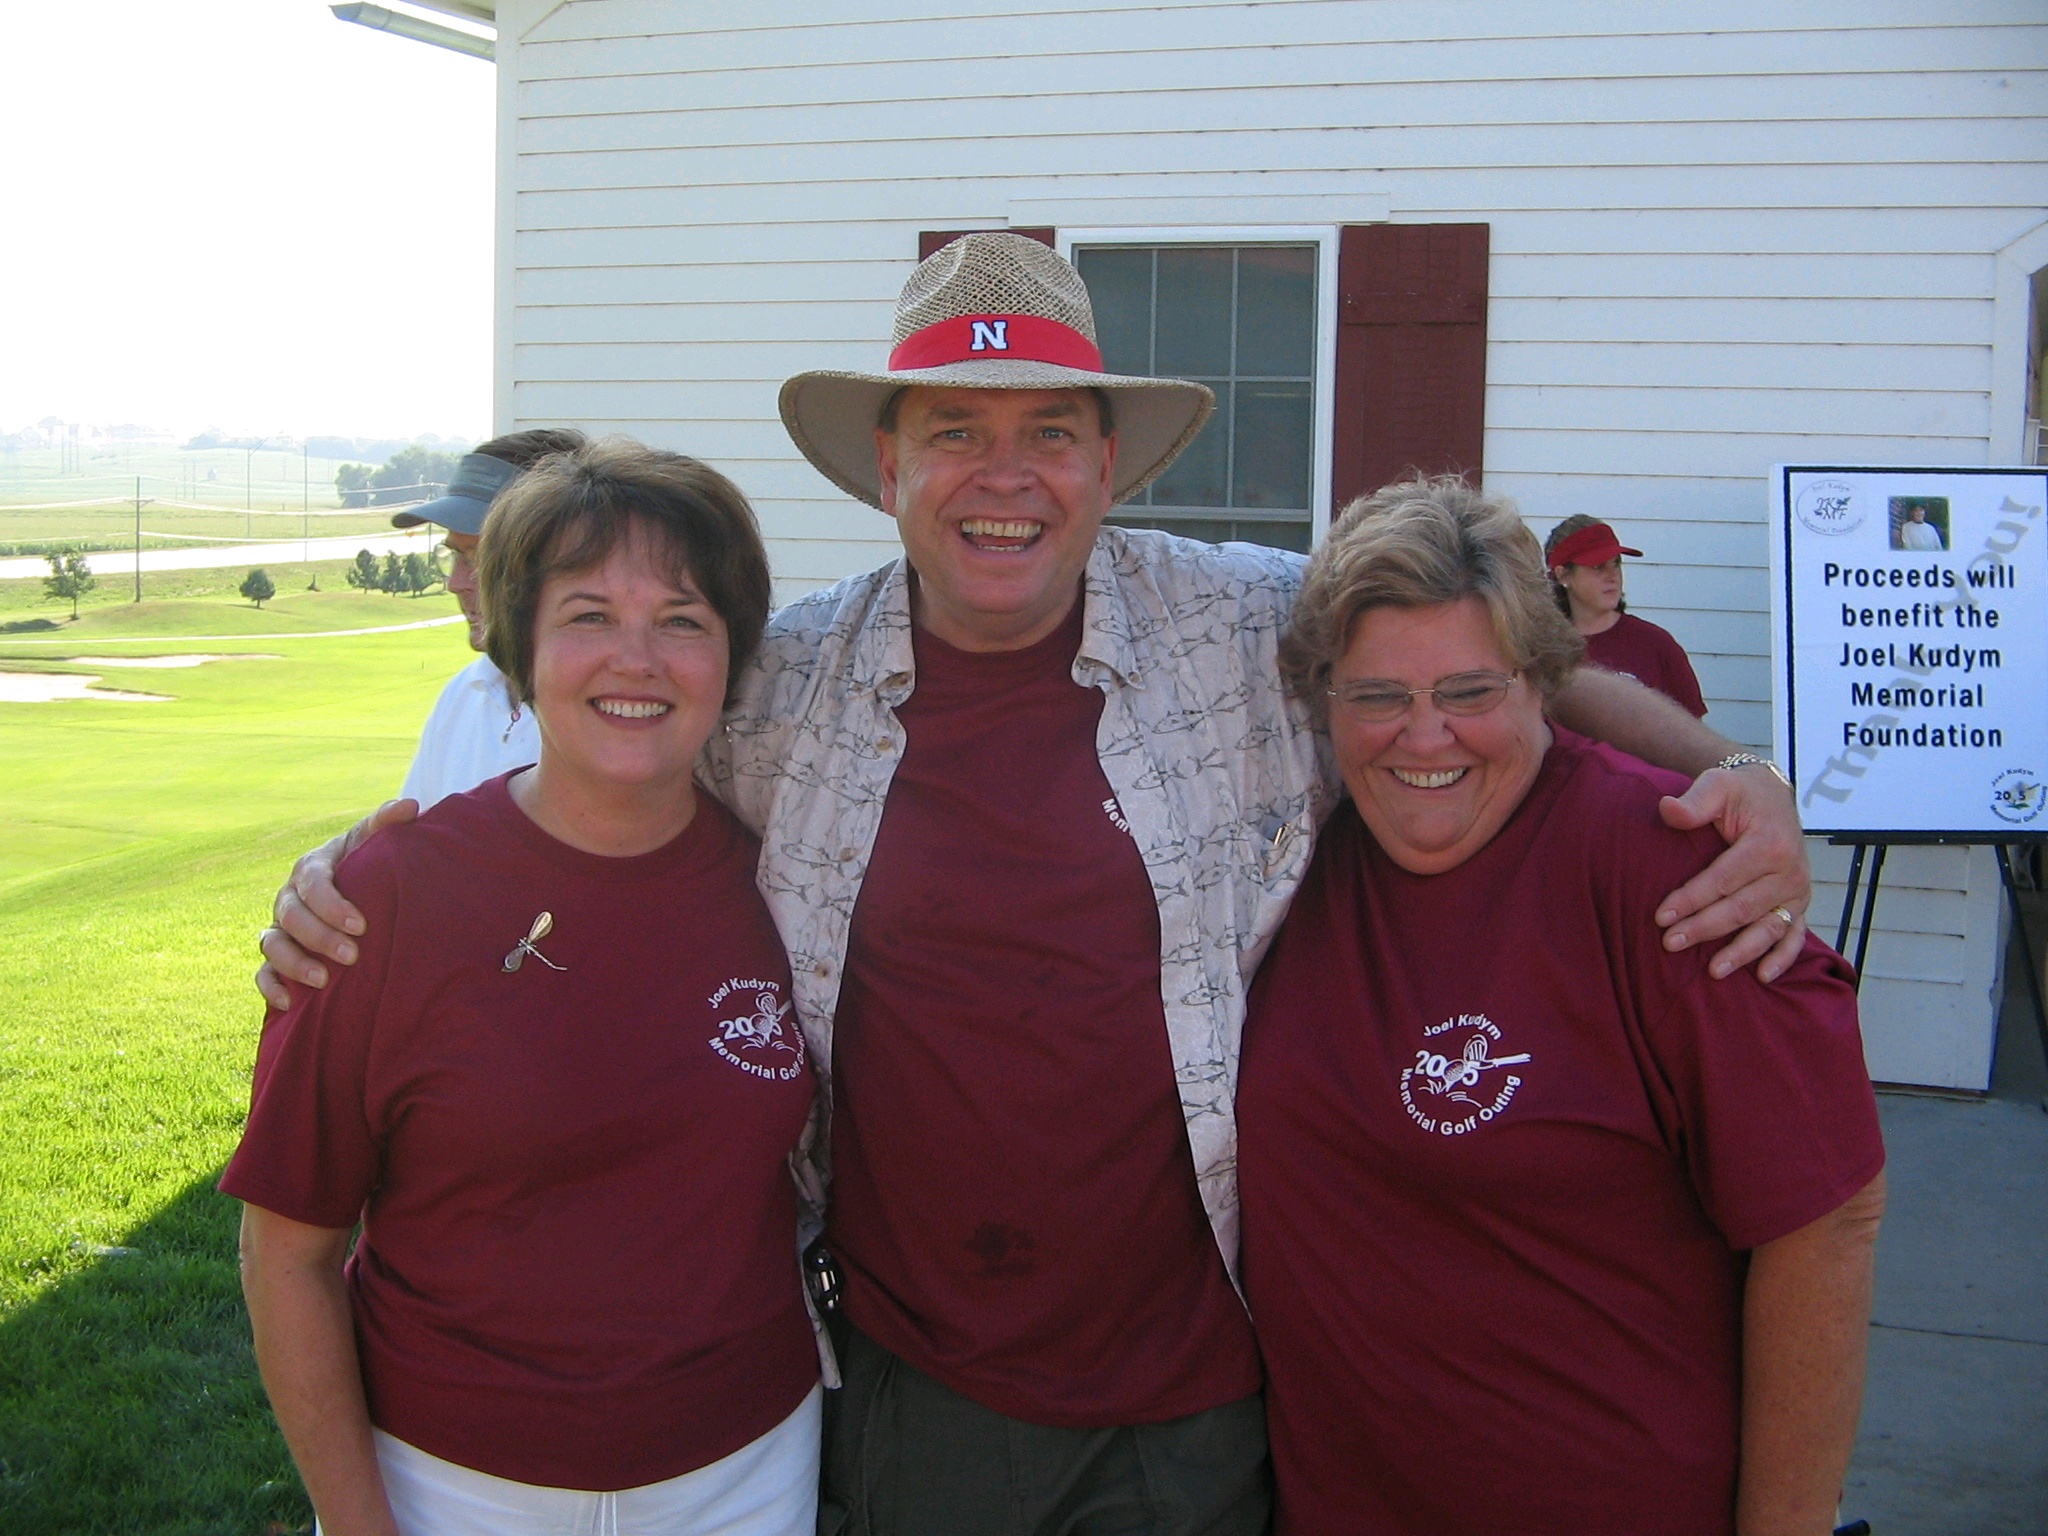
1237, 731, 1884, 1536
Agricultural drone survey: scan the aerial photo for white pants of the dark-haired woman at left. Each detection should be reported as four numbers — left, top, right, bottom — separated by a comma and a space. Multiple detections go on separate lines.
339, 1386, 823, 1536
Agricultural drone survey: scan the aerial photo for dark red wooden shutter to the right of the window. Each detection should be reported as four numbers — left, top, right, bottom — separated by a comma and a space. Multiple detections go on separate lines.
1331, 223, 1489, 514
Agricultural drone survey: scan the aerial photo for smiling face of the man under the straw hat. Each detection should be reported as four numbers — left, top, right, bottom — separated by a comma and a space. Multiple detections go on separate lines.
874, 387, 1116, 651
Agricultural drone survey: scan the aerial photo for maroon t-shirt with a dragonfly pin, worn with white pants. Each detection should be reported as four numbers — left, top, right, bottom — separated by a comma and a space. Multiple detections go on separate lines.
221, 778, 817, 1489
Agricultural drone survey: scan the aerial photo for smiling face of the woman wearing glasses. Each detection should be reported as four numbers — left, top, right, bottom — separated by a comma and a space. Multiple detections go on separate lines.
1329, 596, 1550, 874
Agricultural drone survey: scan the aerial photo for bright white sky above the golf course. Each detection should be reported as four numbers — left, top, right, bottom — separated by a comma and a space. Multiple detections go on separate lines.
0, 0, 496, 438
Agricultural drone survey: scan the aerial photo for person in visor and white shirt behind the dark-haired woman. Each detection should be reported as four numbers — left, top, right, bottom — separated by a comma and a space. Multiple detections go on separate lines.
391, 426, 584, 811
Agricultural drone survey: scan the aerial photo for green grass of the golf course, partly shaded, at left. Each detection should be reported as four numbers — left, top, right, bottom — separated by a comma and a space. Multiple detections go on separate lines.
0, 585, 469, 1536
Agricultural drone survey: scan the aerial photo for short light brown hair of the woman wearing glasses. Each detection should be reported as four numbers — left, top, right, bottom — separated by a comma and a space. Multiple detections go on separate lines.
1280, 475, 1585, 717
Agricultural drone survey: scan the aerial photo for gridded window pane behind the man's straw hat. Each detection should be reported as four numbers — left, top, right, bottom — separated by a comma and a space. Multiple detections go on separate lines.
1073, 244, 1319, 551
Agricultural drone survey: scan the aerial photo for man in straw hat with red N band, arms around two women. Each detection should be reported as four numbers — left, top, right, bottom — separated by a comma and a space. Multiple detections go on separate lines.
266, 233, 1804, 1536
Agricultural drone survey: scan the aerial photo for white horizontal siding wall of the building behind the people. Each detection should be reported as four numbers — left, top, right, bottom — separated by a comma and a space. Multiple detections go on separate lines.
498, 0, 2048, 1085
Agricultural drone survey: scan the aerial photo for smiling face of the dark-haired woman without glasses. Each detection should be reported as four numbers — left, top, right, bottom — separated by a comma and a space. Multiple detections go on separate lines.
532, 530, 727, 846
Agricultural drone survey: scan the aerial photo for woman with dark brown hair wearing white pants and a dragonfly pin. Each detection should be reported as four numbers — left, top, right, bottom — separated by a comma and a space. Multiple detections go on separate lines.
221, 440, 819, 1536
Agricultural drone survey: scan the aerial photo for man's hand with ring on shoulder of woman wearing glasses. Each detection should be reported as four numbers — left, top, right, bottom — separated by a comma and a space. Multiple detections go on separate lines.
1657, 766, 1812, 981
